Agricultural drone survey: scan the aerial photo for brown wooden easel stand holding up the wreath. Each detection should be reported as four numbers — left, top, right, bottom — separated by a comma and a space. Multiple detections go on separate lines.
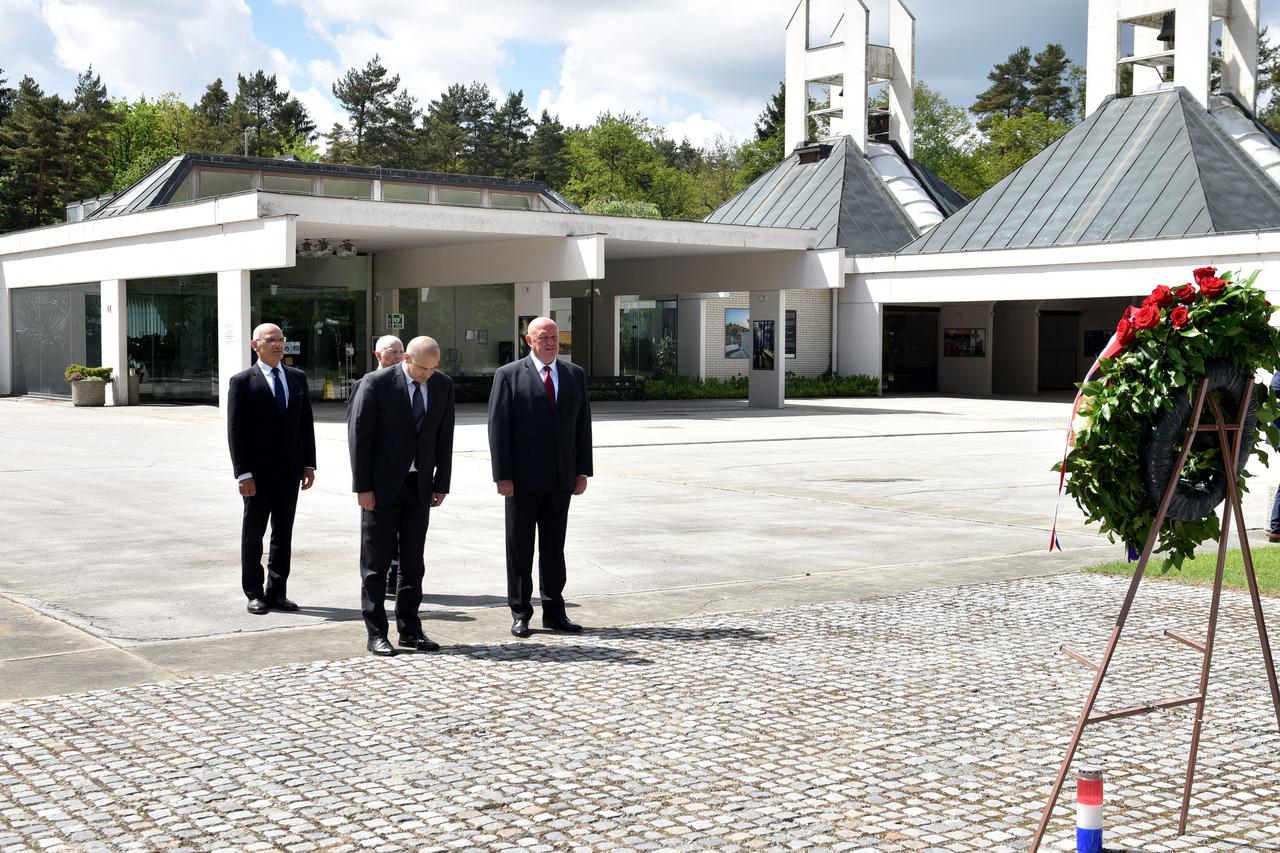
1030, 379, 1280, 853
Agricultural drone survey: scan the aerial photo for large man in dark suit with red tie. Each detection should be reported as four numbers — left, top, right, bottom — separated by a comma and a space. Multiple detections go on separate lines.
489, 316, 593, 637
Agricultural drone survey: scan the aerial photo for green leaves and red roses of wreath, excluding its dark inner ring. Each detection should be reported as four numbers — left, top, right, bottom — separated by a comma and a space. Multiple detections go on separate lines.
1053, 266, 1280, 571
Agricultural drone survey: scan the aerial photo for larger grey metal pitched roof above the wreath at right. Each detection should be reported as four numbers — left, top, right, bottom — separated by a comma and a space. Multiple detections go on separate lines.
901, 88, 1280, 255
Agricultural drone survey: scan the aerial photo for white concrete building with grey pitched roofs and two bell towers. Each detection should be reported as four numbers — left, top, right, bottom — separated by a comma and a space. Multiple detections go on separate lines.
0, 0, 1280, 407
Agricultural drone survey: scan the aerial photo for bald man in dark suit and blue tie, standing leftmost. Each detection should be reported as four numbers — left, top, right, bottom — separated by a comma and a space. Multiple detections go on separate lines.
227, 323, 316, 615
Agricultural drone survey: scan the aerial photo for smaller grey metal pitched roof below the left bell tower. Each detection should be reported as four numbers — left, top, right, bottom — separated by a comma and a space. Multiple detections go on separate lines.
703, 137, 919, 255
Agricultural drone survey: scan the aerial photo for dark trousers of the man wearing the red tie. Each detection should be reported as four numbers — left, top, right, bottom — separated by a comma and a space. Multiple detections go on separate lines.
506, 489, 573, 619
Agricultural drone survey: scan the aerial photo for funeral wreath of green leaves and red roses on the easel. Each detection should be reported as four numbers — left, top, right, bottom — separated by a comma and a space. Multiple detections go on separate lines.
1053, 266, 1280, 570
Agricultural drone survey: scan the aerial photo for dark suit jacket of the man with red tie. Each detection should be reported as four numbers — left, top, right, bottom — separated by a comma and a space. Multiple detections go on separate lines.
489, 356, 593, 493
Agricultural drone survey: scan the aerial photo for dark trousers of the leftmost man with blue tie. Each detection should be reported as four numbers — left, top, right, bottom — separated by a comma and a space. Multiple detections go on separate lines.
241, 458, 298, 601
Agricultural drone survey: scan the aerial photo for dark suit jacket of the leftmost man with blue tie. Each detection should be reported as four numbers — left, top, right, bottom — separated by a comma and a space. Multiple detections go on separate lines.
227, 364, 316, 483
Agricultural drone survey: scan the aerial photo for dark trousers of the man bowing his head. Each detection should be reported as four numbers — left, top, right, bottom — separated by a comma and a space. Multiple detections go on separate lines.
360, 473, 431, 637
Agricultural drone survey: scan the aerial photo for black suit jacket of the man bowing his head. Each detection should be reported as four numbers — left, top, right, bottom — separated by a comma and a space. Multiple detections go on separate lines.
347, 365, 454, 506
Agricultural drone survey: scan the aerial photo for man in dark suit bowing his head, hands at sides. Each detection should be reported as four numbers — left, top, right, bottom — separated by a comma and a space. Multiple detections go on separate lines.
347, 337, 453, 656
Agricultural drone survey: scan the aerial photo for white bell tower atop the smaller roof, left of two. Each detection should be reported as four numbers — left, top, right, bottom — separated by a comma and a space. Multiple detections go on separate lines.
785, 0, 915, 156
